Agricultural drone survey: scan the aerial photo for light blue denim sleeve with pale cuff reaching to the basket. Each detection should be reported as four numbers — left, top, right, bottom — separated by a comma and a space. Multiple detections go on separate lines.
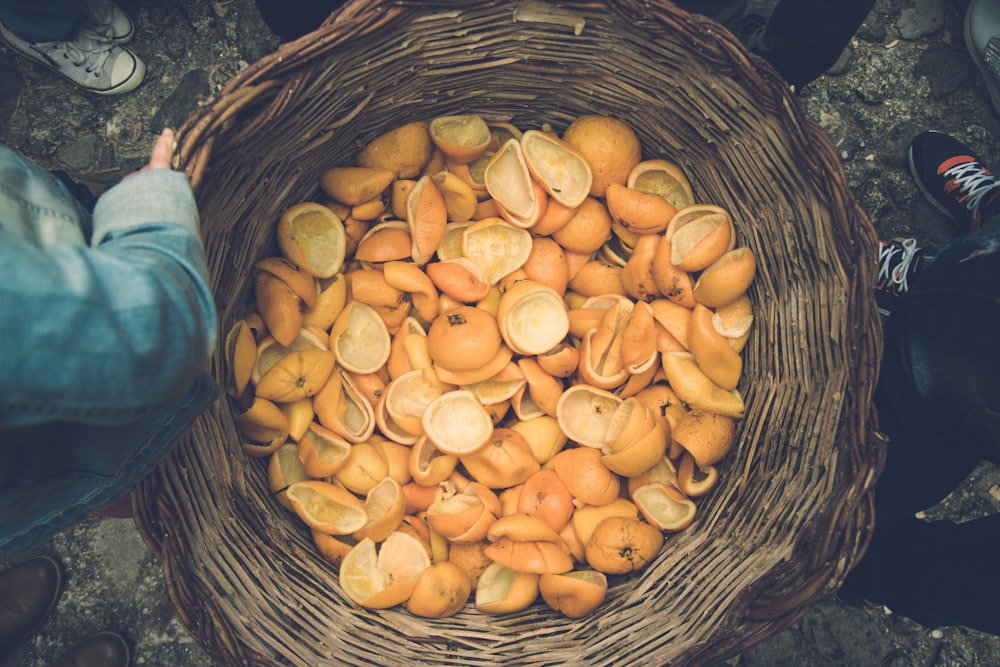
0, 169, 217, 426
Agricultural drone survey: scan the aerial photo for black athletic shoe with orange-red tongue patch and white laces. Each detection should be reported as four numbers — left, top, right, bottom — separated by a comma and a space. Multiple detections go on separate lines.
910, 130, 1000, 231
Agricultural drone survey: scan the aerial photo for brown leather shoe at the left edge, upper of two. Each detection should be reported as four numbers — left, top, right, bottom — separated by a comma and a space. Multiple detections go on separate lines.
0, 556, 63, 658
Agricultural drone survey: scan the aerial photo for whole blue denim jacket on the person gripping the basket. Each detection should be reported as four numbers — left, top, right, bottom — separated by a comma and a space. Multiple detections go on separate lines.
0, 147, 218, 556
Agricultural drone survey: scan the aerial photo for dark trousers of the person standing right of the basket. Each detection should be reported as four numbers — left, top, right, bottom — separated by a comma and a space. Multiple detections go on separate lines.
846, 222, 1000, 635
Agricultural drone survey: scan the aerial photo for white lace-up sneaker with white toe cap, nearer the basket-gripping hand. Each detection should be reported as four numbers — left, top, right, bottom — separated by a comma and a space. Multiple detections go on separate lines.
0, 23, 146, 95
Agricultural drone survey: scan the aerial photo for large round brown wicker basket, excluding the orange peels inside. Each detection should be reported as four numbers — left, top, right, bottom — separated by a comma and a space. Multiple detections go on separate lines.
135, 0, 882, 665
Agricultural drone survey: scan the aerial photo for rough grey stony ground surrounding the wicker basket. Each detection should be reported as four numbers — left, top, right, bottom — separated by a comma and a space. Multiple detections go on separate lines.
0, 0, 1000, 667
